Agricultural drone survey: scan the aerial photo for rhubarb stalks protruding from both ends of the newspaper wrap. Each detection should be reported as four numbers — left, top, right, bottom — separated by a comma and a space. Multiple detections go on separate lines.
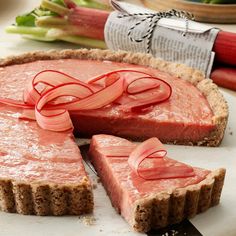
6, 0, 236, 90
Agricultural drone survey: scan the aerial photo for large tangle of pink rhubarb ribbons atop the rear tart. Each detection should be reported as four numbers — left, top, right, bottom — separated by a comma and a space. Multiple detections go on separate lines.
0, 69, 172, 131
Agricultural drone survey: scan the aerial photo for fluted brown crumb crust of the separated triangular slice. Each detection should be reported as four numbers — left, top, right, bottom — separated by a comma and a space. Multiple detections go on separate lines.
130, 169, 225, 232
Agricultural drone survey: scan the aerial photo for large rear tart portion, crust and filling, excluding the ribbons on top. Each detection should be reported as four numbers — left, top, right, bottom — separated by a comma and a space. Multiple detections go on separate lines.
0, 49, 228, 146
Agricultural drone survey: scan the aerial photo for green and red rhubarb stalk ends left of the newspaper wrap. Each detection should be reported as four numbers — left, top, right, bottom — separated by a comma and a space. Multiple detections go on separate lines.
6, 0, 110, 48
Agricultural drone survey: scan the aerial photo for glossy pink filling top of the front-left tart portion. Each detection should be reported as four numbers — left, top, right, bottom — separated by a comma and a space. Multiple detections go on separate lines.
0, 105, 87, 184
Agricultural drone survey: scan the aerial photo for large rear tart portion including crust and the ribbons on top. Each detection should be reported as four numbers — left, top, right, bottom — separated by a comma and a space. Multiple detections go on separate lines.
0, 49, 228, 146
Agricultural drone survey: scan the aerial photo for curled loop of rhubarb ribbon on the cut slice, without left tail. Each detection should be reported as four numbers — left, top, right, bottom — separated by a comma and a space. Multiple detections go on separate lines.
128, 138, 195, 180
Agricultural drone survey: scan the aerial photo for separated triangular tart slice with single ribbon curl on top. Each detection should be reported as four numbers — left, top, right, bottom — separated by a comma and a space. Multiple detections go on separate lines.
89, 135, 225, 232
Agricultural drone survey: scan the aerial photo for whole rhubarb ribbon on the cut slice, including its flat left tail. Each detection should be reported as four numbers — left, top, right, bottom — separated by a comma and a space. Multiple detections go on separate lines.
98, 137, 195, 180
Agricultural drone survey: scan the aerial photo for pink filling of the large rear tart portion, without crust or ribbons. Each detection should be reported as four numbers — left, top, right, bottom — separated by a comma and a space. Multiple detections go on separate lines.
0, 59, 215, 142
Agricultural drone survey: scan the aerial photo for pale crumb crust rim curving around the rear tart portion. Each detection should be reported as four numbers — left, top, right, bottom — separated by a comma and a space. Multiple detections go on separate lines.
0, 49, 228, 146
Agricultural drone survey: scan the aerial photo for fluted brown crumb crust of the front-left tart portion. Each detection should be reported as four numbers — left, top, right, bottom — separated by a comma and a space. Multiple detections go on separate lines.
0, 177, 94, 216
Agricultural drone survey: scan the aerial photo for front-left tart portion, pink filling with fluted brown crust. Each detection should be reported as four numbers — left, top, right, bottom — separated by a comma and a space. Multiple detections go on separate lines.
0, 105, 93, 215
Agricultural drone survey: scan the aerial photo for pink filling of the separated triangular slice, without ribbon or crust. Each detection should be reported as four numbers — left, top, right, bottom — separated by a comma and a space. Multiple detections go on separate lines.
89, 135, 210, 222
